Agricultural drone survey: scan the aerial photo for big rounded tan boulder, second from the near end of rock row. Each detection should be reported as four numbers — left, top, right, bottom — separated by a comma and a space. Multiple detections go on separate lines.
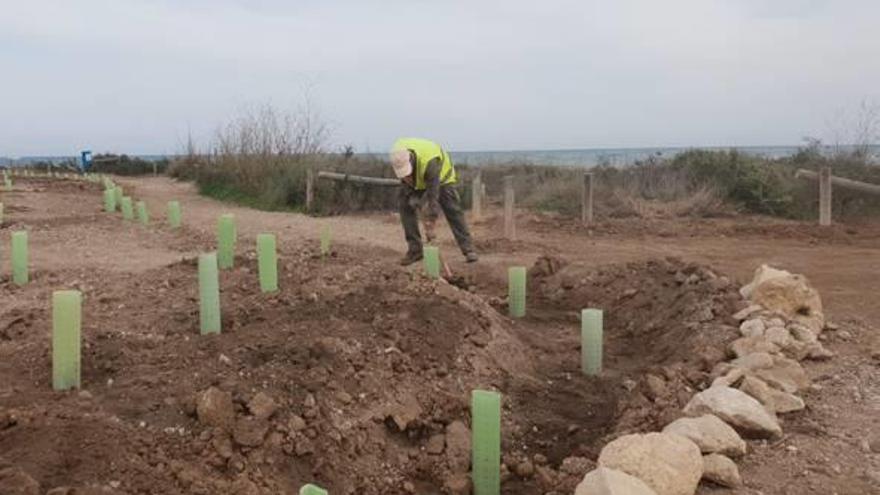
599, 433, 703, 495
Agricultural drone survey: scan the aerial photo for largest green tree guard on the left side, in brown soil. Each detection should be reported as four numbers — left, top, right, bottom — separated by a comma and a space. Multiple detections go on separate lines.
52, 290, 82, 390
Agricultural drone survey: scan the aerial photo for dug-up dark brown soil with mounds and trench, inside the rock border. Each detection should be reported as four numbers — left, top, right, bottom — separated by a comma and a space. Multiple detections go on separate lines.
0, 177, 740, 495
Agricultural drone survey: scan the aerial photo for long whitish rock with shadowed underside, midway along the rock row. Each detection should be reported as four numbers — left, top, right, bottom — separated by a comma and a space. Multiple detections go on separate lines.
684, 386, 782, 438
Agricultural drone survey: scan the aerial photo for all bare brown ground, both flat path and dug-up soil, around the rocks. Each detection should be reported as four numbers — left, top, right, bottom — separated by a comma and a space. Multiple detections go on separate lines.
0, 178, 880, 495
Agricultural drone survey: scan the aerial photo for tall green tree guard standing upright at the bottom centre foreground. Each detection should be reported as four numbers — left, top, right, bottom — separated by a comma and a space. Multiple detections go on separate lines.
471, 390, 501, 495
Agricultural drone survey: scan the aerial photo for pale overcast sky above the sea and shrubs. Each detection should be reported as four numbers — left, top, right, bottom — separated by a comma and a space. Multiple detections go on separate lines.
0, 0, 880, 156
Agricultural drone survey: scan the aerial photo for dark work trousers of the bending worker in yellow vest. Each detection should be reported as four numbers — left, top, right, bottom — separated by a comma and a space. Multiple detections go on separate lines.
399, 184, 474, 254
